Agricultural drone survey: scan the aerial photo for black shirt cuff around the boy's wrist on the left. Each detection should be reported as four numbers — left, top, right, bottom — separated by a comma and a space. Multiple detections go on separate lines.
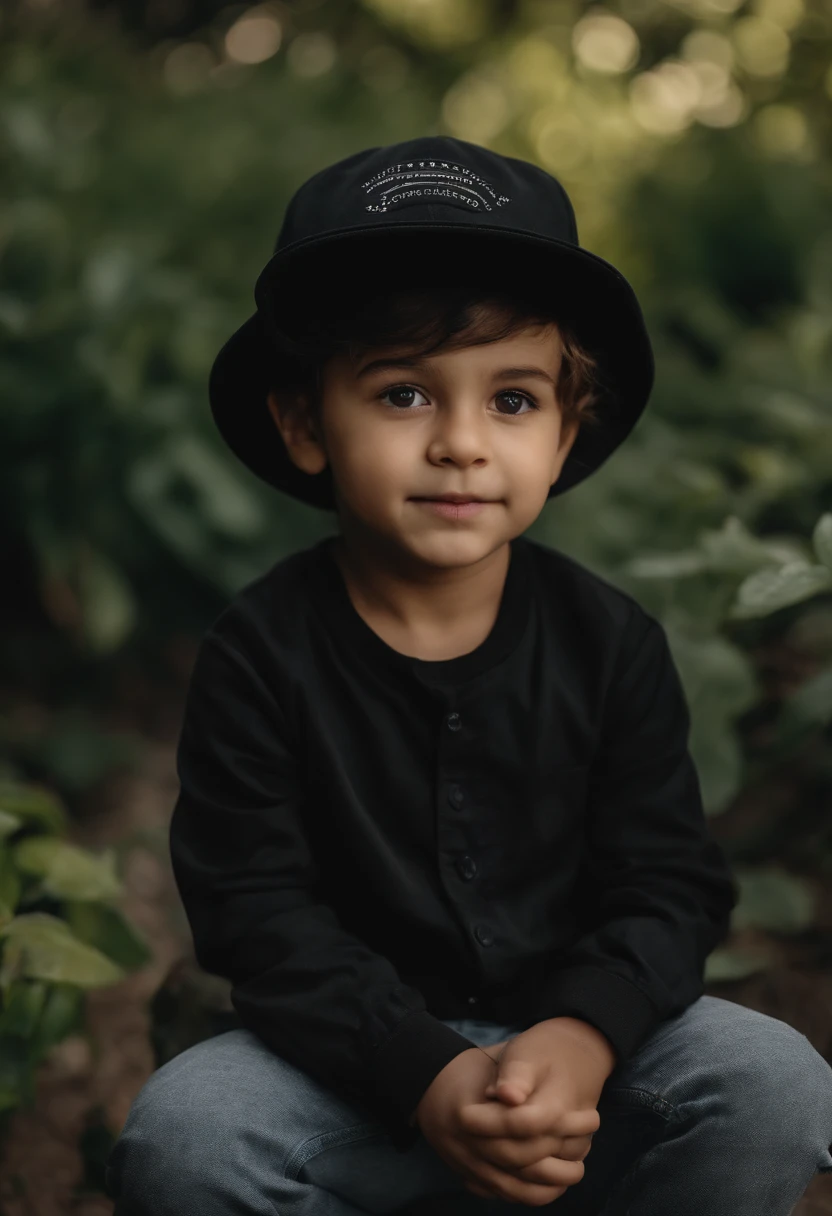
370, 1010, 477, 1150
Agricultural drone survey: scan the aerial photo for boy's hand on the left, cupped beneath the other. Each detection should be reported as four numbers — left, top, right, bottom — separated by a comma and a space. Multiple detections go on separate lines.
416, 1045, 600, 1207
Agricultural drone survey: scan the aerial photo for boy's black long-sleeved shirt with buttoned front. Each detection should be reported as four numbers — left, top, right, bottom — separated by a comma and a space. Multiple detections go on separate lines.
170, 536, 738, 1150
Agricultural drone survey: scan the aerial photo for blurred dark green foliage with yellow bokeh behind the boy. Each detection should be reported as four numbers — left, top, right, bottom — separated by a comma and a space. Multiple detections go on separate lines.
0, 0, 832, 1118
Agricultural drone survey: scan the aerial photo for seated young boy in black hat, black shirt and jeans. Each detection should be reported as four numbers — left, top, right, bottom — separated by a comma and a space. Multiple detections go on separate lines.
108, 137, 832, 1216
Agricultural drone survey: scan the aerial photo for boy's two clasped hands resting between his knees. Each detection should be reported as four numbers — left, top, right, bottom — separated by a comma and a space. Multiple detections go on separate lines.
420, 1018, 614, 1206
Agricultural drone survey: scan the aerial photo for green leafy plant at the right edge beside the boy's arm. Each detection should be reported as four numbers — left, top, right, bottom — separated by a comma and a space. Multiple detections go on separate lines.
625, 513, 832, 980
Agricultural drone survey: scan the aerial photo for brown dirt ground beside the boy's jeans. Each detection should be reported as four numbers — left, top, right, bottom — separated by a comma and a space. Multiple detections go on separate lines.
0, 729, 832, 1216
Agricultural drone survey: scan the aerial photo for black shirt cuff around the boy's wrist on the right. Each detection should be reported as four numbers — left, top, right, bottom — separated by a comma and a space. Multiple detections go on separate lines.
538, 967, 662, 1066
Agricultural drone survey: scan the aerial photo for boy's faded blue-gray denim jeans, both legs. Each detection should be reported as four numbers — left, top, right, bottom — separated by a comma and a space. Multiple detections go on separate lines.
107, 996, 832, 1216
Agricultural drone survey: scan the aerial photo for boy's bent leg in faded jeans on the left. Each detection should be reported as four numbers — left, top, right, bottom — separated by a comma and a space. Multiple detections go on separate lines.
106, 1029, 471, 1214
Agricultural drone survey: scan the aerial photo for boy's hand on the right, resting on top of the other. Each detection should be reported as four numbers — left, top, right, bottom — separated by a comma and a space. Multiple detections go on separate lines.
452, 1018, 615, 1197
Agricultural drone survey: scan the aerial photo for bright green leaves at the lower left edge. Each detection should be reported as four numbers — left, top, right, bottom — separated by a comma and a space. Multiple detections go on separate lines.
0, 781, 151, 1127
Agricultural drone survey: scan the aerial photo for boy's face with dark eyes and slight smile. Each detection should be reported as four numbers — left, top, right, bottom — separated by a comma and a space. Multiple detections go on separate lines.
269, 325, 578, 567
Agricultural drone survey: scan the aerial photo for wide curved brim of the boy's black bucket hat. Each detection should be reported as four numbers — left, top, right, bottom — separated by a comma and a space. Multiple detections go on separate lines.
208, 221, 654, 511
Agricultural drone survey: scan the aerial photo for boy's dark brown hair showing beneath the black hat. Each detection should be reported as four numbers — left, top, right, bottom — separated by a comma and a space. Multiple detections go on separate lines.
271, 282, 602, 440
